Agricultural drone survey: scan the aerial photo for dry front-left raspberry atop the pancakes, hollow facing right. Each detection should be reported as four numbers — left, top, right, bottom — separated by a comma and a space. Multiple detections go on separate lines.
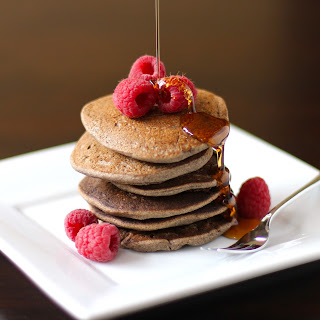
113, 79, 157, 118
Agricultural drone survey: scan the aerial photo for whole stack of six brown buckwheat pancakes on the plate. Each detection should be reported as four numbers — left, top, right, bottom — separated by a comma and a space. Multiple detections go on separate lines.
71, 89, 234, 252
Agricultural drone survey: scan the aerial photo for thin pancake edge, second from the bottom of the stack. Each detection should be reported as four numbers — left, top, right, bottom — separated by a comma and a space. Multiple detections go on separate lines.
90, 202, 227, 231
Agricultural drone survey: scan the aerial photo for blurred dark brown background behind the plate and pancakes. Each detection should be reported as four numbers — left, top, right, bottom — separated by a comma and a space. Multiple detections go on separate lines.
0, 0, 320, 167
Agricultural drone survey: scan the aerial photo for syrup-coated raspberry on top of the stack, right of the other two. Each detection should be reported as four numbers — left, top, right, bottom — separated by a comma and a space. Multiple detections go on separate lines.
157, 76, 197, 113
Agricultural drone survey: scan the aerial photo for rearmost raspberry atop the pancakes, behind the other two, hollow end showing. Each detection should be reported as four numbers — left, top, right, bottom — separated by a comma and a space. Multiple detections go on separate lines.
129, 55, 166, 81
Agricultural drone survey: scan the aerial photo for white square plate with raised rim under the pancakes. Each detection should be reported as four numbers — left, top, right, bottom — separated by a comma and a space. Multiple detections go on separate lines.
0, 126, 320, 319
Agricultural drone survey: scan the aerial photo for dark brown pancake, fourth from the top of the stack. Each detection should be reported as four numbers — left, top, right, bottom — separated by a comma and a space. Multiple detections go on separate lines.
79, 177, 220, 220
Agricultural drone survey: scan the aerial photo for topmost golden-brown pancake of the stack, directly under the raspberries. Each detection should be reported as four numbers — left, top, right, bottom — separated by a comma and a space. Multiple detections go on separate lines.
81, 89, 228, 163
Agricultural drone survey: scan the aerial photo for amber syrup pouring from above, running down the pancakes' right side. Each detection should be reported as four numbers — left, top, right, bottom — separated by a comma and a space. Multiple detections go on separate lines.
156, 0, 245, 239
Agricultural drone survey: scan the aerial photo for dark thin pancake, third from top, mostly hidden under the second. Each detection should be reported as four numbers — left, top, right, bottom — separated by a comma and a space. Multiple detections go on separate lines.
114, 156, 217, 197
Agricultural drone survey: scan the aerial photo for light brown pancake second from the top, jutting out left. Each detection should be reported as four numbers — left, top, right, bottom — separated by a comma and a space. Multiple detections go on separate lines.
71, 132, 213, 185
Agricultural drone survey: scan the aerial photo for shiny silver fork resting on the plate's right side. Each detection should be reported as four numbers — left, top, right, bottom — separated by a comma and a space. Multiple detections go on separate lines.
217, 174, 320, 253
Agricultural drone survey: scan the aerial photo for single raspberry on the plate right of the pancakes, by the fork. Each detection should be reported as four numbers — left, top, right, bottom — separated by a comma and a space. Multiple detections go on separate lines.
237, 177, 271, 220
